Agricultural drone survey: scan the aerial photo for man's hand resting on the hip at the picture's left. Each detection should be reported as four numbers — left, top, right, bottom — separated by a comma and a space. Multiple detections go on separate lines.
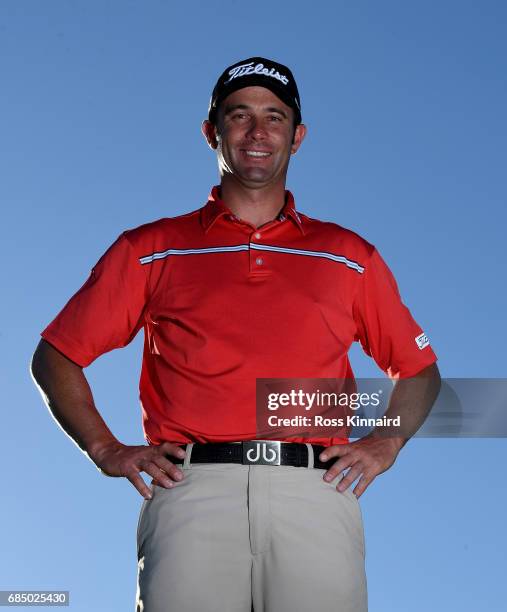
90, 441, 185, 499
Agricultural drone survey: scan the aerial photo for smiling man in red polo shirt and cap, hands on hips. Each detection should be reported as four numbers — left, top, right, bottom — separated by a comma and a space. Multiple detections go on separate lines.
32, 57, 439, 612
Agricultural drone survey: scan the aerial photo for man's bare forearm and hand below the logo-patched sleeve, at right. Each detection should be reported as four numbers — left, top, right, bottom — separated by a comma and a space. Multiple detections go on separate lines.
320, 364, 441, 497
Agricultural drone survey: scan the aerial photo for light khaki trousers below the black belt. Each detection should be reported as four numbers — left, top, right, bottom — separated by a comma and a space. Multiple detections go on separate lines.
136, 452, 367, 612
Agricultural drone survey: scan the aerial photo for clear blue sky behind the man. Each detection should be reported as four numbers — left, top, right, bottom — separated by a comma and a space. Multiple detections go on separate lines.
0, 0, 507, 612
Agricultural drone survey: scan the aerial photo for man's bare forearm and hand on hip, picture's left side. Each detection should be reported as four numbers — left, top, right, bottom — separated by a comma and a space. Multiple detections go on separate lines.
31, 340, 185, 498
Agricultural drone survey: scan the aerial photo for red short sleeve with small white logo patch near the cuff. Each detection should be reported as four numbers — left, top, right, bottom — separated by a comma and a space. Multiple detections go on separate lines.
353, 249, 437, 378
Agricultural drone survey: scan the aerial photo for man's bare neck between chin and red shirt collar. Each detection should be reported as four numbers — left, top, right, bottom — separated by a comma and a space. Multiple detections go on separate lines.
220, 177, 285, 227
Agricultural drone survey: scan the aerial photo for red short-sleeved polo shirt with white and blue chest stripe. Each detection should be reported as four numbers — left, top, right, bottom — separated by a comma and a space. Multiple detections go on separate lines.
42, 187, 436, 445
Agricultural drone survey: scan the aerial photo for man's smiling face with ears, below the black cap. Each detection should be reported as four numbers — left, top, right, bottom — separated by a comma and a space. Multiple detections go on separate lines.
203, 87, 305, 188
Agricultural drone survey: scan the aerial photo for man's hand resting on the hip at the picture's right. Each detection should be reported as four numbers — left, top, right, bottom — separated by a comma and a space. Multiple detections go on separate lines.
320, 436, 403, 498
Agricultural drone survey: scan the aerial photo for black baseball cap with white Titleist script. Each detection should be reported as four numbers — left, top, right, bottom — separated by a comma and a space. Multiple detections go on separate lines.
208, 57, 301, 124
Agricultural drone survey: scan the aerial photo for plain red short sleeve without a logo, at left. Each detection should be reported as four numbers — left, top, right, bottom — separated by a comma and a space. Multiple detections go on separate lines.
41, 233, 147, 367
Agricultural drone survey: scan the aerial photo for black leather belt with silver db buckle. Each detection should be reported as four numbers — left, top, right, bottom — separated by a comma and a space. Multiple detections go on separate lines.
170, 440, 338, 470
